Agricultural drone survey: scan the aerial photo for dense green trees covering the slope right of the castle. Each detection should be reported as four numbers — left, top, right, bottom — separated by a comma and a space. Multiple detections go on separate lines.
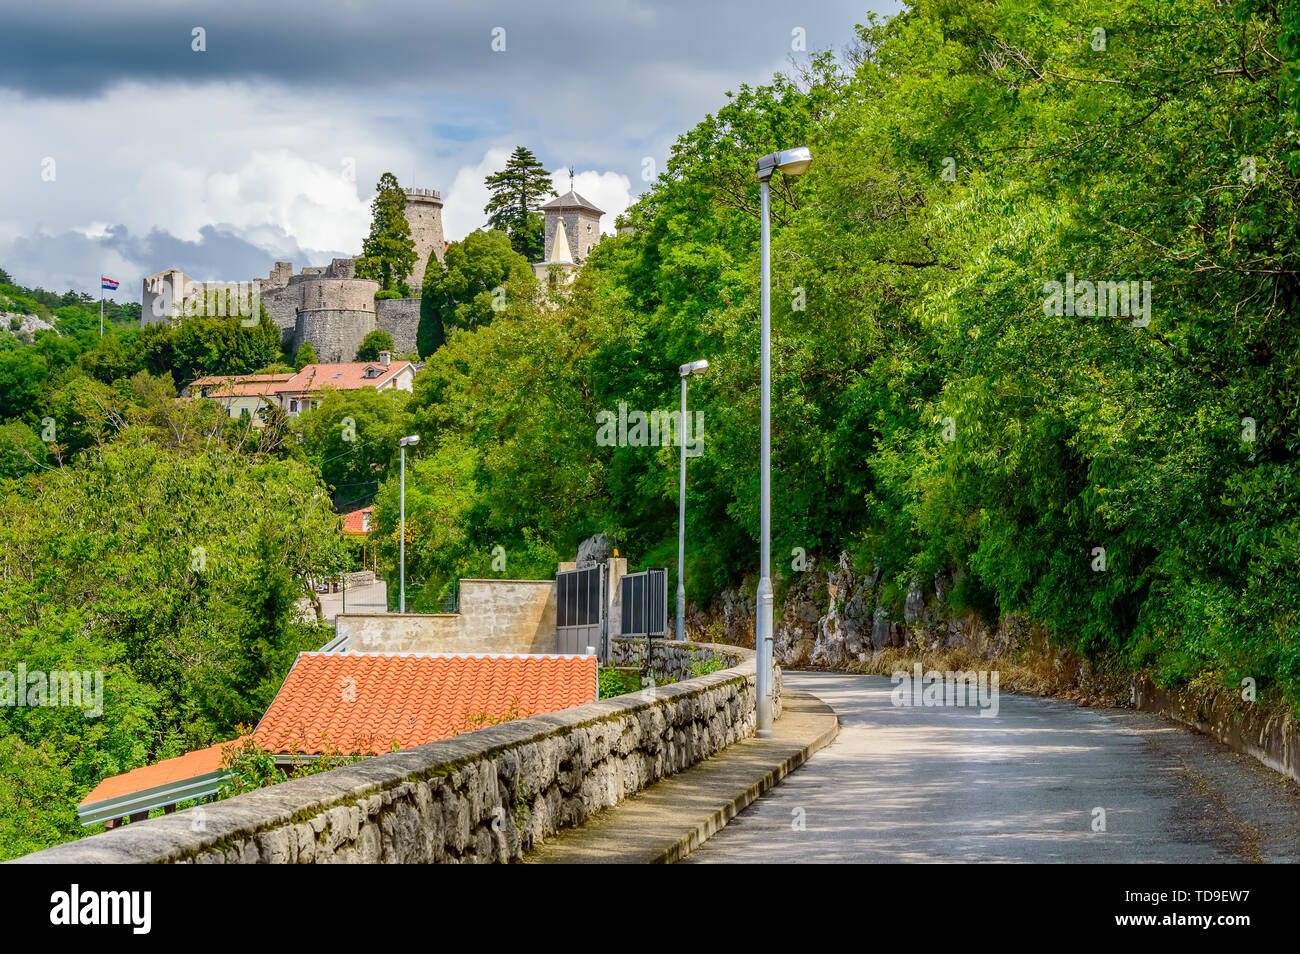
390, 0, 1300, 702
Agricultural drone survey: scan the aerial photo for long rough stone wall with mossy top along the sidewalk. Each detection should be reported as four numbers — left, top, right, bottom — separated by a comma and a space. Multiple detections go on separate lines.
18, 643, 769, 864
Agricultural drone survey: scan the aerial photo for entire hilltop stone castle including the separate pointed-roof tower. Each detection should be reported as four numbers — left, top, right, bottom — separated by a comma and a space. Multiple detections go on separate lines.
140, 180, 605, 364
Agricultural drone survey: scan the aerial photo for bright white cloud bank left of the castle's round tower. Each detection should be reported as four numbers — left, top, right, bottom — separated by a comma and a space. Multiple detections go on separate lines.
0, 83, 428, 295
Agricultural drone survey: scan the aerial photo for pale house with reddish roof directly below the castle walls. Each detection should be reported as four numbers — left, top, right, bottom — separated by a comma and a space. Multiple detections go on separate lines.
185, 351, 415, 426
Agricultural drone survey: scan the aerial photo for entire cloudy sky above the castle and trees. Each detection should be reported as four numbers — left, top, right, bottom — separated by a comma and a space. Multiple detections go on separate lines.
0, 0, 898, 302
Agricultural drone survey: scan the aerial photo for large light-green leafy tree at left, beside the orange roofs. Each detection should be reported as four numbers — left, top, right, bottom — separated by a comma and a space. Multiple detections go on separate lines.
0, 436, 345, 857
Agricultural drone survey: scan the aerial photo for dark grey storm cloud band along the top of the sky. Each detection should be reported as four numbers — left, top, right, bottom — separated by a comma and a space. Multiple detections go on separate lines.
0, 0, 868, 96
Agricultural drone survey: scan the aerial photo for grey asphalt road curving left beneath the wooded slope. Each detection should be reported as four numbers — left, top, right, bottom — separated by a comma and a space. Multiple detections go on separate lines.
685, 673, 1300, 864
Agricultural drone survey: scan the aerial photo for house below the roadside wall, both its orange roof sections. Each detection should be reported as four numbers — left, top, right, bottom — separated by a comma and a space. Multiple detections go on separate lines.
77, 652, 599, 828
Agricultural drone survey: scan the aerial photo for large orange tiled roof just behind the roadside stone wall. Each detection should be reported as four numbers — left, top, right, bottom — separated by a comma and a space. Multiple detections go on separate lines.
252, 652, 597, 755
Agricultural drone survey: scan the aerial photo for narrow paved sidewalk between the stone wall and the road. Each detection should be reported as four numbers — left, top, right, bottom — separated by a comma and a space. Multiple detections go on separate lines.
524, 689, 839, 864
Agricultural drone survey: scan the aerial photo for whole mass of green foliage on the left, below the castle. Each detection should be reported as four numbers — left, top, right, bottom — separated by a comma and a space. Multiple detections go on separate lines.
0, 283, 353, 857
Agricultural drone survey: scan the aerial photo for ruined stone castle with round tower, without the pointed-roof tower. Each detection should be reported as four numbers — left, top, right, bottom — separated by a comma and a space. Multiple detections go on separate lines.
140, 188, 446, 363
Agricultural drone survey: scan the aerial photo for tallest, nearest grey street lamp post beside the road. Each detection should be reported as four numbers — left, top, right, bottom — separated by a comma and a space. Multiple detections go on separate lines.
754, 146, 813, 738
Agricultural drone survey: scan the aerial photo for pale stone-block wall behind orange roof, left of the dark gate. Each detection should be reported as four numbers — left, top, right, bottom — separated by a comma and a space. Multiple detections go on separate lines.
334, 580, 555, 652
